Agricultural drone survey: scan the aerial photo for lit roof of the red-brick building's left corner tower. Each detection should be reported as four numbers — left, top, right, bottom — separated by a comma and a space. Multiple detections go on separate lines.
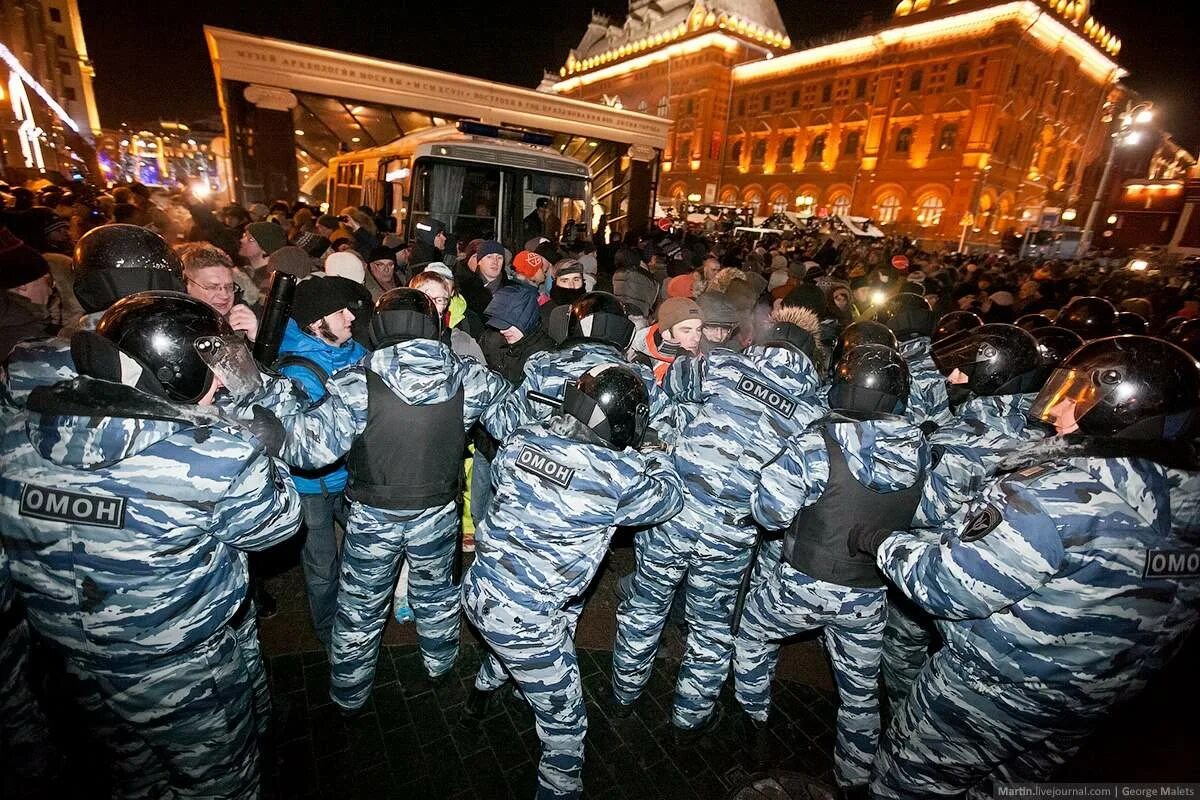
558, 0, 792, 78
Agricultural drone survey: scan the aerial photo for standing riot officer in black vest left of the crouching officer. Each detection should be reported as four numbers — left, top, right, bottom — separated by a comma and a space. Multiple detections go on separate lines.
319, 288, 511, 711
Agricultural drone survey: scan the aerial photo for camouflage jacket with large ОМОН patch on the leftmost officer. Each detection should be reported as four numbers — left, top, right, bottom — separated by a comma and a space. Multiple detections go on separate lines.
0, 378, 300, 663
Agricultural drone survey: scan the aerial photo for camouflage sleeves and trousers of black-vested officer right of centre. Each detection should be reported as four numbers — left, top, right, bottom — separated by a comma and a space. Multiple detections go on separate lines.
733, 419, 929, 787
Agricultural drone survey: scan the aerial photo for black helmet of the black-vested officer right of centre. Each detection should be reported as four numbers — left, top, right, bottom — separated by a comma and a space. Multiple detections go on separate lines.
829, 344, 912, 419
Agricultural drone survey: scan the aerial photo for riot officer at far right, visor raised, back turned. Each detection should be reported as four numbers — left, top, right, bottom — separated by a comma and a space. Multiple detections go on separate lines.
871, 336, 1200, 799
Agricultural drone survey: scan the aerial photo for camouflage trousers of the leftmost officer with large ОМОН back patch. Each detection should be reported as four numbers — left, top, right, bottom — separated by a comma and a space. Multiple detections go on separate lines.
58, 628, 260, 799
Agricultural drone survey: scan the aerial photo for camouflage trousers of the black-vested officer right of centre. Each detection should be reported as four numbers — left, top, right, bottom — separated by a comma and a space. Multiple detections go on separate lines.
733, 564, 887, 787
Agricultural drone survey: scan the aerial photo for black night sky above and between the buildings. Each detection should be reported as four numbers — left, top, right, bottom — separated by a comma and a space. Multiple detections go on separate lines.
79, 0, 1200, 154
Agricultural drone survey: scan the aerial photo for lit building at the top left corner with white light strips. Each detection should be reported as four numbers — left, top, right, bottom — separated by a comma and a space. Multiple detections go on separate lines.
0, 0, 100, 181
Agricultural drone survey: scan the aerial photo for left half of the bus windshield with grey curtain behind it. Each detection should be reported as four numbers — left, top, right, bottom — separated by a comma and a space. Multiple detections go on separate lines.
410, 158, 500, 241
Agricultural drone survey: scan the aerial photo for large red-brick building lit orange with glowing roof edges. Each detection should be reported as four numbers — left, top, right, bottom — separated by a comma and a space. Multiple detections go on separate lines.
549, 0, 1124, 243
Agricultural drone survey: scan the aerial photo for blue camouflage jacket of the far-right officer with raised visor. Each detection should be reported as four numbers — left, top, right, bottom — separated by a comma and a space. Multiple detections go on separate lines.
877, 457, 1200, 702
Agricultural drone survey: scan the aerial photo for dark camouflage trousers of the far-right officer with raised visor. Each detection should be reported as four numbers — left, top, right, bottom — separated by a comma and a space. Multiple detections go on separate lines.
871, 649, 1108, 800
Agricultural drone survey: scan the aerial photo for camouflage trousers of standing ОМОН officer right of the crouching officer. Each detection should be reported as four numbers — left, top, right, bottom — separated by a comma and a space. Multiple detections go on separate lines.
612, 503, 751, 728
